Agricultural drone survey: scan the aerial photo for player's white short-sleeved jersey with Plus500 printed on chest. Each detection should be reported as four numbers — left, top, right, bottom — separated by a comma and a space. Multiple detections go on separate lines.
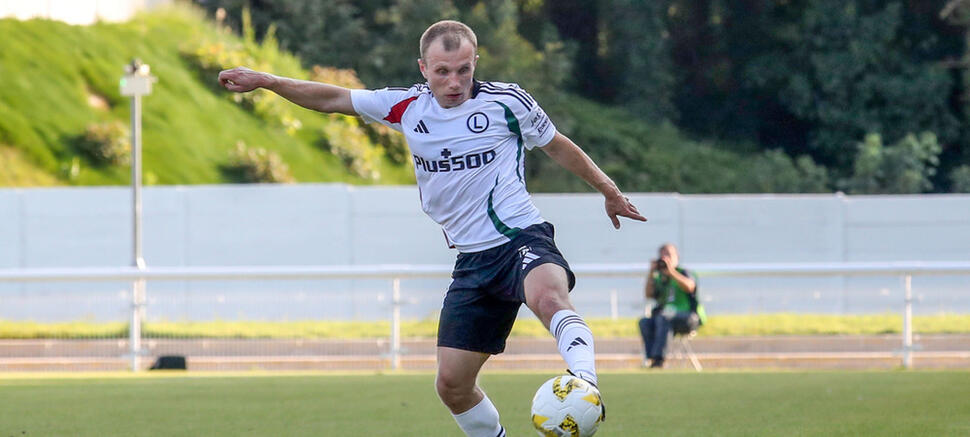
350, 81, 556, 252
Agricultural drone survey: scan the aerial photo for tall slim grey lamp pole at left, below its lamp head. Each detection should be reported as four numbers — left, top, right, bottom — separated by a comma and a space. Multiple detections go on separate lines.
128, 94, 145, 372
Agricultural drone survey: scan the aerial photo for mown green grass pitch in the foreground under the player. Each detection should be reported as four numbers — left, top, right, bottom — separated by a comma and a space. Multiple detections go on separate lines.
0, 371, 970, 437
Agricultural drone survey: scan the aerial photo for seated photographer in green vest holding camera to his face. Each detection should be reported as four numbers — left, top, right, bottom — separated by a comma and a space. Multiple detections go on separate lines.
640, 243, 706, 368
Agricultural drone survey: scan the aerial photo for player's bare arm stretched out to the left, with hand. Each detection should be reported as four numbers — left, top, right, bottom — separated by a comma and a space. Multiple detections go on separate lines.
219, 67, 357, 115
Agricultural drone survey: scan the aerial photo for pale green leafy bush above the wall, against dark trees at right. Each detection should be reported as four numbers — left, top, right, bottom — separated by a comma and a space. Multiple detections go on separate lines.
842, 132, 941, 194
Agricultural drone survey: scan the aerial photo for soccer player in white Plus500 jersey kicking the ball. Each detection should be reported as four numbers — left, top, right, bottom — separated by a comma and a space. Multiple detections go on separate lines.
219, 21, 646, 437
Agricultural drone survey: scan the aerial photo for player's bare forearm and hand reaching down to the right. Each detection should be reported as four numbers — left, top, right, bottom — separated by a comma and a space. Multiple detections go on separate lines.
542, 132, 647, 229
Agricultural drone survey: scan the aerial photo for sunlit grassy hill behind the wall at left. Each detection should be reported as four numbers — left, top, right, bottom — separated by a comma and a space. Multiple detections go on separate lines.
0, 8, 413, 186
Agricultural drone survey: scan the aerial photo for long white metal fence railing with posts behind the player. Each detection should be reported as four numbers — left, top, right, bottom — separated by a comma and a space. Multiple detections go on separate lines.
0, 261, 970, 371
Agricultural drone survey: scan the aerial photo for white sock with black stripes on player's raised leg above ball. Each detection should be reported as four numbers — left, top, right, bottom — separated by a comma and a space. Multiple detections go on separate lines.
549, 310, 596, 384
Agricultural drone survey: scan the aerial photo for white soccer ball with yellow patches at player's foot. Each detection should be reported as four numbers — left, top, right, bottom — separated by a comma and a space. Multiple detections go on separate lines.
532, 375, 603, 437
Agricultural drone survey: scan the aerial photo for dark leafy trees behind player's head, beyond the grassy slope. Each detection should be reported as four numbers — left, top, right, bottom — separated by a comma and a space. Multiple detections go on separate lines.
191, 0, 970, 192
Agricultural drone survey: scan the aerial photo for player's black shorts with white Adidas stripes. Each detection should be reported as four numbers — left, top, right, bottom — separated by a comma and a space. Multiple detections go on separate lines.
438, 223, 576, 354
